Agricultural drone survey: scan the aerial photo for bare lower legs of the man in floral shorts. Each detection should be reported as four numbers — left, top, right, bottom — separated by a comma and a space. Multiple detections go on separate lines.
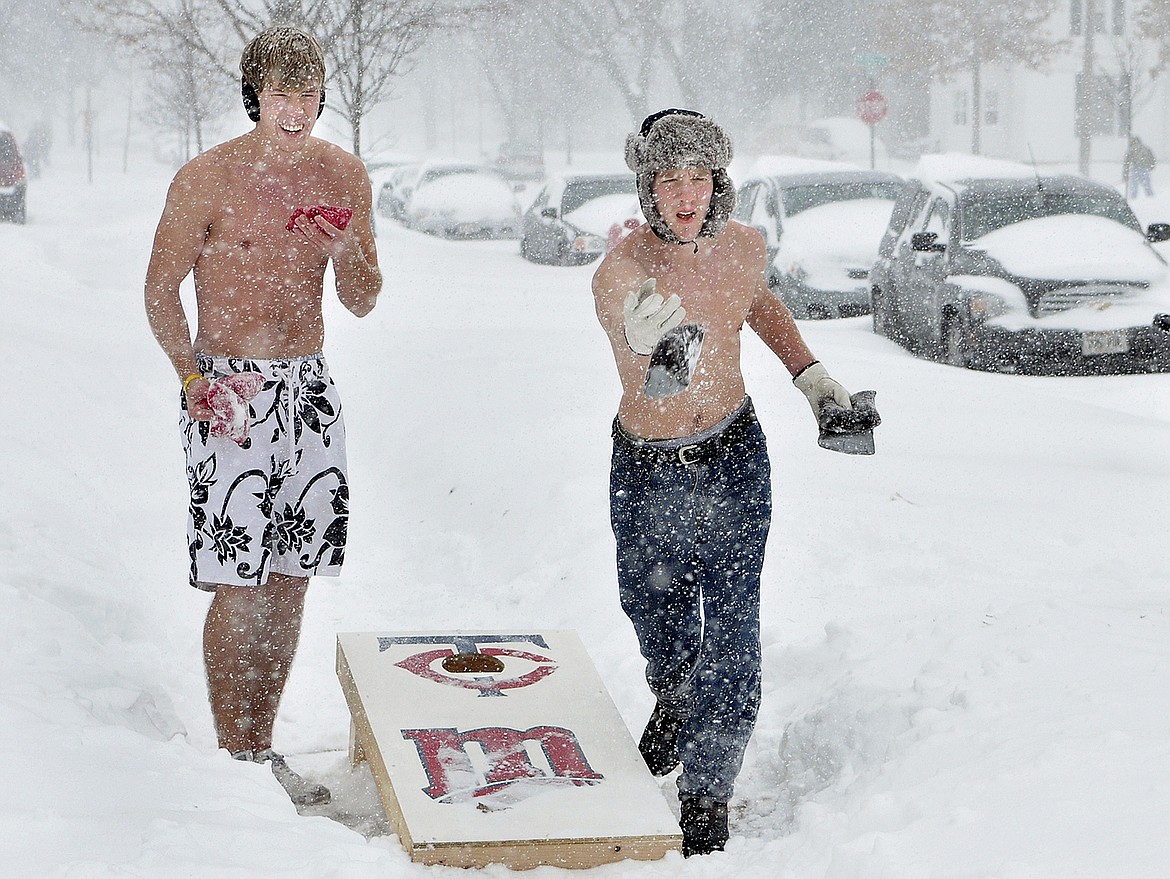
204, 574, 309, 754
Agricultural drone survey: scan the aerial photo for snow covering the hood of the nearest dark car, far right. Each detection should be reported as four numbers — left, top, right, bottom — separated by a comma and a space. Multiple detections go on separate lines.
970, 214, 1166, 283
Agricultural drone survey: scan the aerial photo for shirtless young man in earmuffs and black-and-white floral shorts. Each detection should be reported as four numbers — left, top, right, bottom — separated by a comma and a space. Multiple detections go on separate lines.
146, 27, 381, 804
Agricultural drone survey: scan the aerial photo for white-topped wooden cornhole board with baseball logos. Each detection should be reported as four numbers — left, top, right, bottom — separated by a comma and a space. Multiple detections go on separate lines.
337, 631, 682, 868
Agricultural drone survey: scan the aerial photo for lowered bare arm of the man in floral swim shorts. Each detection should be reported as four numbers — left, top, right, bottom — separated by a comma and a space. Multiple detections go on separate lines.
145, 165, 214, 379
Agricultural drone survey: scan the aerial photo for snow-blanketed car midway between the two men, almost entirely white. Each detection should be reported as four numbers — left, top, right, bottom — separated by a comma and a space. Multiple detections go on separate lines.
405, 169, 519, 239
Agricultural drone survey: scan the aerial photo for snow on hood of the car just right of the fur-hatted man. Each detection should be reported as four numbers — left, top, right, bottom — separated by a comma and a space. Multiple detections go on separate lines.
775, 199, 894, 290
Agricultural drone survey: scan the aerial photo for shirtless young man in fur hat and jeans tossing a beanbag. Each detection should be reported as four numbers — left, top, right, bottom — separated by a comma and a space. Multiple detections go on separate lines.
593, 110, 851, 857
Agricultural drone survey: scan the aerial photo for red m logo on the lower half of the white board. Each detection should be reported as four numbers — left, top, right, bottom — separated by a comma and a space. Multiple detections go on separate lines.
402, 727, 605, 805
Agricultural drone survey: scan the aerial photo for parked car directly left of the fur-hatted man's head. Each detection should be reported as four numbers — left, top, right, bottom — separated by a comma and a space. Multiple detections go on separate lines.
519, 174, 641, 266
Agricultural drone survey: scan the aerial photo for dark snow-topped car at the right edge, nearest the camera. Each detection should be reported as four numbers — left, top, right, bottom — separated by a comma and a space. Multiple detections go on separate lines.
870, 156, 1170, 375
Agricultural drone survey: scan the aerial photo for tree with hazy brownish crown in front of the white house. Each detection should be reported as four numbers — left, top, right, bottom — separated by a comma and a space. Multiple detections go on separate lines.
875, 0, 1067, 153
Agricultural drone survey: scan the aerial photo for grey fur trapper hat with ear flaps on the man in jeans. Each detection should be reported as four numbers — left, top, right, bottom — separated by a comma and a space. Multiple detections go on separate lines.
626, 110, 735, 245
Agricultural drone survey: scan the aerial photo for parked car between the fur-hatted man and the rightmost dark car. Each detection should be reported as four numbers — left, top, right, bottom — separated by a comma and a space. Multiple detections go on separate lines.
735, 159, 902, 318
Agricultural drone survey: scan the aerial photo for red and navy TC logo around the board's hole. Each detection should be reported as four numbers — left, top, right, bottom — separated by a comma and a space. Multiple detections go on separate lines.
378, 634, 557, 696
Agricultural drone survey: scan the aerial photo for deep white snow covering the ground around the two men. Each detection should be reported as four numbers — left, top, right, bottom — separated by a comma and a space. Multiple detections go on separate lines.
0, 148, 1170, 879
